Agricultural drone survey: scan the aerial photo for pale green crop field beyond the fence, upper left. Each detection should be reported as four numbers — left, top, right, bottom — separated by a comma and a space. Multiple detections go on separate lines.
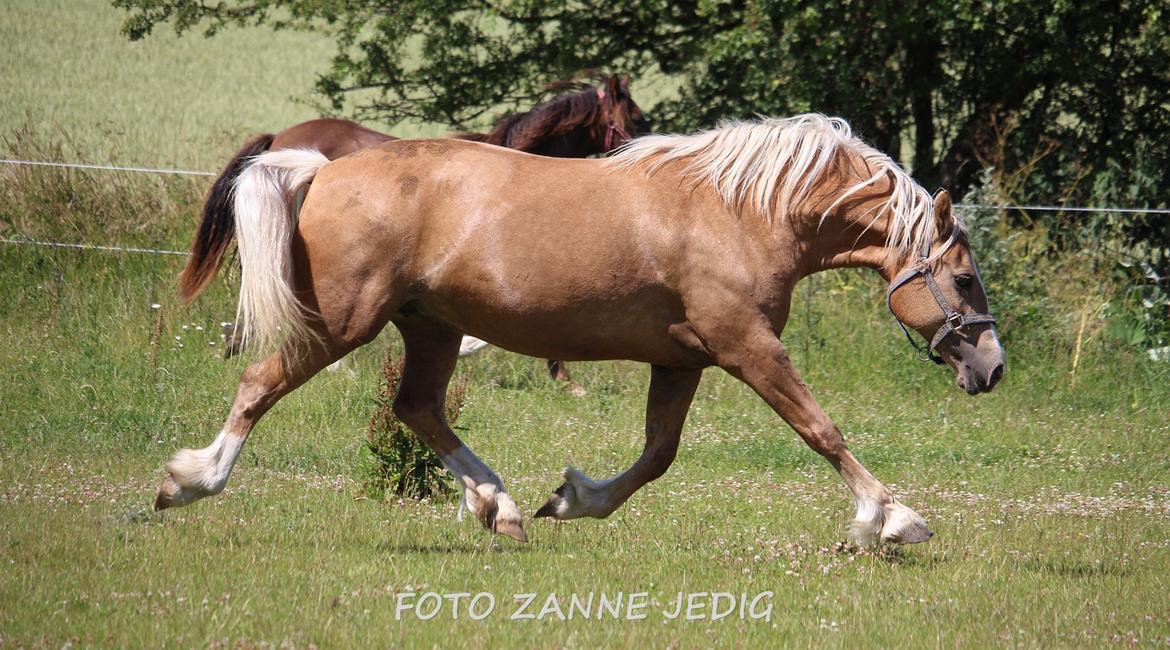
0, 0, 443, 170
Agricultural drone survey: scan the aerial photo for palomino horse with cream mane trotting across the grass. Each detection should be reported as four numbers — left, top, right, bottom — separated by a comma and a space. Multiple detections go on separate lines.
156, 115, 1004, 544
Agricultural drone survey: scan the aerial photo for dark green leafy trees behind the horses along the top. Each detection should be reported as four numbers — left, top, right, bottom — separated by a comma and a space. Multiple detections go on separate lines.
113, 0, 1170, 208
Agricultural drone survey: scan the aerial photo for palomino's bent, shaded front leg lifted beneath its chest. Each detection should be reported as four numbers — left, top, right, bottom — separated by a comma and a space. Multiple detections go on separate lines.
536, 366, 703, 519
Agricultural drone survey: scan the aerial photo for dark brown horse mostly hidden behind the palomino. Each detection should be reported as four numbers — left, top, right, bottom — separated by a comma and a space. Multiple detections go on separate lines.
179, 76, 651, 395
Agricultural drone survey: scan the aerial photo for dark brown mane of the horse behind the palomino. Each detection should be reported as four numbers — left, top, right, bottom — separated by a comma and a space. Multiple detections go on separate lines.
459, 81, 601, 151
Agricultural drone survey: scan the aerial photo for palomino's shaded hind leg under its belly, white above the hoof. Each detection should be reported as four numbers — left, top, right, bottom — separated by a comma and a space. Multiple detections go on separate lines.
394, 317, 528, 541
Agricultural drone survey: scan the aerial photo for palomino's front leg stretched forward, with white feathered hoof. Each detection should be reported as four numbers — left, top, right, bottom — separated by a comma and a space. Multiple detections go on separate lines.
709, 323, 932, 545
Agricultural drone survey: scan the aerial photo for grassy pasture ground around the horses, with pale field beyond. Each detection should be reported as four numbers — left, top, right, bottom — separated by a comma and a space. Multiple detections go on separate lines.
0, 0, 1170, 648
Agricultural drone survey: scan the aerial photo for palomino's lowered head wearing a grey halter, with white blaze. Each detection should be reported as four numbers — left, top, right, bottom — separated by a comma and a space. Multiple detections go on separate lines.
886, 191, 1004, 395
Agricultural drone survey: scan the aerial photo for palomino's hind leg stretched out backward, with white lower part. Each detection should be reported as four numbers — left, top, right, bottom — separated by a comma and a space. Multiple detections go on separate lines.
154, 343, 356, 510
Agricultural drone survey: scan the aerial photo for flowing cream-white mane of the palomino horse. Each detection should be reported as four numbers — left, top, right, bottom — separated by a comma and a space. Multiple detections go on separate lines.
606, 113, 934, 254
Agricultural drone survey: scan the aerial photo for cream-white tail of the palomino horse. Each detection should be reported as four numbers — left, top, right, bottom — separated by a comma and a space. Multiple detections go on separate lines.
234, 148, 329, 350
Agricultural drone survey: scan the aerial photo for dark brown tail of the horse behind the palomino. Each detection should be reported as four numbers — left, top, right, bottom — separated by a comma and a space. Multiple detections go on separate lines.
179, 133, 275, 303
